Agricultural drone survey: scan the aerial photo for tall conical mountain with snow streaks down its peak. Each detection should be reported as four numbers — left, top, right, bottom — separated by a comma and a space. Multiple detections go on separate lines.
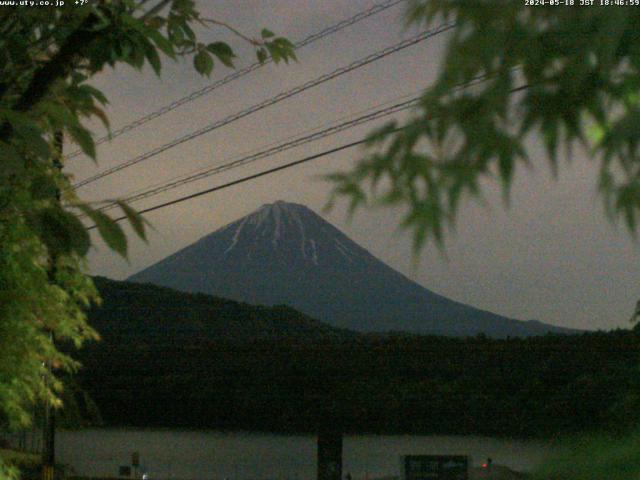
129, 201, 566, 337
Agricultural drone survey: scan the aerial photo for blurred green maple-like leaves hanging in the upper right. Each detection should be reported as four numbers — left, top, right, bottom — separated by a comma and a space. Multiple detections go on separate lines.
332, 0, 640, 248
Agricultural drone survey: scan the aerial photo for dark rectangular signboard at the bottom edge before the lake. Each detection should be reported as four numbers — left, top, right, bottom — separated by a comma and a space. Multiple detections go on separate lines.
400, 455, 469, 480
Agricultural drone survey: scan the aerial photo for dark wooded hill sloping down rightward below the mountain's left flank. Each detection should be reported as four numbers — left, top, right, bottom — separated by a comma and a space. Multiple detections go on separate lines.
88, 277, 357, 347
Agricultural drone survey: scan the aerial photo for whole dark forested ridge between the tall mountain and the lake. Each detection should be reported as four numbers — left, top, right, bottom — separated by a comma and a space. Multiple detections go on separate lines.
80, 279, 640, 437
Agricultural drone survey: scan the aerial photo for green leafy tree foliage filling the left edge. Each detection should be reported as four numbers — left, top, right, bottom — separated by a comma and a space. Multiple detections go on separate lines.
0, 0, 295, 478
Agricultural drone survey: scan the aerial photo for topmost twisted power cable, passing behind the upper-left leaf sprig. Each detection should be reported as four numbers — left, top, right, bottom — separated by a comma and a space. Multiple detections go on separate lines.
66, 0, 406, 159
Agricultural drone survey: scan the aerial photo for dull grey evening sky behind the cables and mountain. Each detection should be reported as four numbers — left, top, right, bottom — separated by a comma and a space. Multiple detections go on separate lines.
67, 0, 640, 329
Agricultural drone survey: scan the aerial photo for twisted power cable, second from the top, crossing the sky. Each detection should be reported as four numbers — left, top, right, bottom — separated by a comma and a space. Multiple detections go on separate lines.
73, 22, 455, 188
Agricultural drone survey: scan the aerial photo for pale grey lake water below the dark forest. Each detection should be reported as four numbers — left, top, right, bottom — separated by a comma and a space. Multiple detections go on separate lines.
56, 429, 550, 480
